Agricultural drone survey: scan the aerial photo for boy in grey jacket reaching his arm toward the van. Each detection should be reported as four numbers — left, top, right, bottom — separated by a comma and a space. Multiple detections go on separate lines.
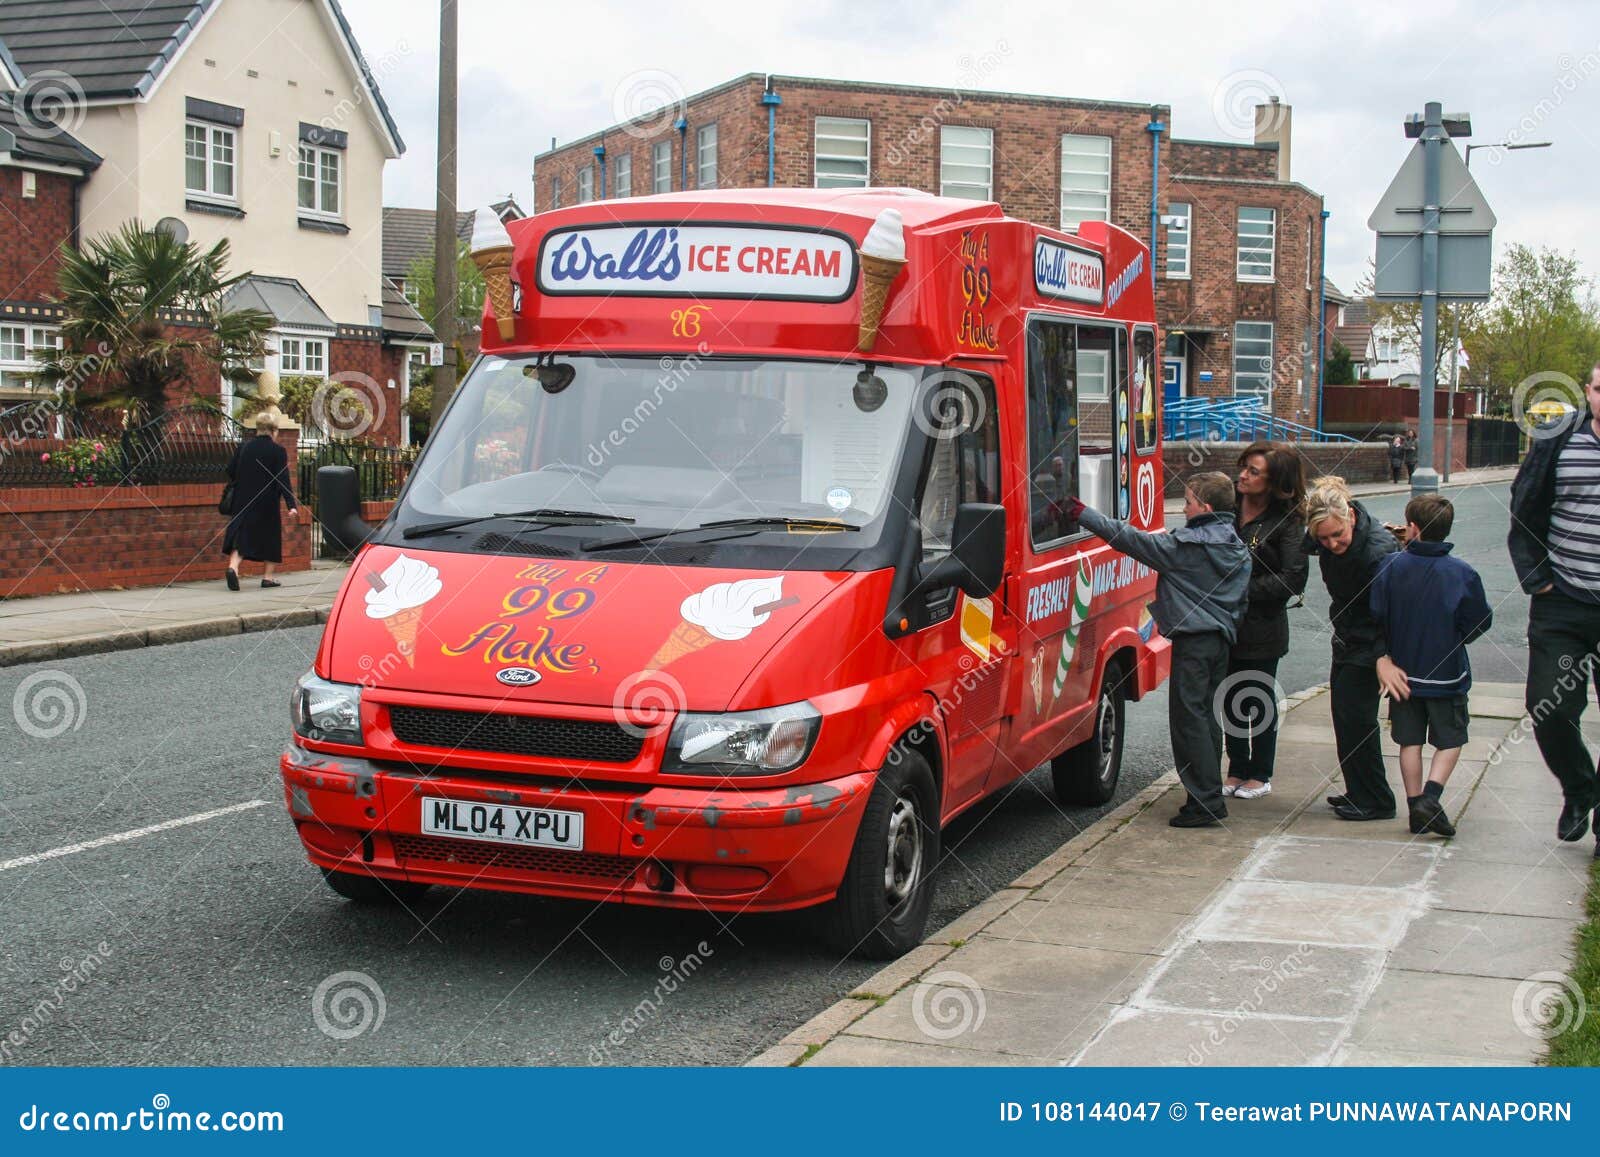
1067, 470, 1250, 827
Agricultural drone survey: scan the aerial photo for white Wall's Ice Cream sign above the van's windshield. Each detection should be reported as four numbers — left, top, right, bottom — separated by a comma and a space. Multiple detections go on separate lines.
539, 224, 856, 301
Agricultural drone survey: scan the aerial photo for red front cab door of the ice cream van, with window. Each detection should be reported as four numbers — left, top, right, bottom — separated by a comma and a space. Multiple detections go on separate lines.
917, 370, 1018, 813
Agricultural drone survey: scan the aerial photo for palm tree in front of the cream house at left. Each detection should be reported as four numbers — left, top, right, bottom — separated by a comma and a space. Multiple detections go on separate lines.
40, 221, 274, 424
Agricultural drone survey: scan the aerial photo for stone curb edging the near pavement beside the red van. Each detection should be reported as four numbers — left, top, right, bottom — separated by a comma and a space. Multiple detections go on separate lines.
744, 683, 1328, 1069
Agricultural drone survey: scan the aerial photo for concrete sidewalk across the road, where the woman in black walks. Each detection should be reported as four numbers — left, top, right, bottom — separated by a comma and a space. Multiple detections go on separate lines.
0, 562, 347, 667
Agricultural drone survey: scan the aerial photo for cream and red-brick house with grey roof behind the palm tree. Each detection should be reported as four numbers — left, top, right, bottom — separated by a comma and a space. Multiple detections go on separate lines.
0, 0, 432, 443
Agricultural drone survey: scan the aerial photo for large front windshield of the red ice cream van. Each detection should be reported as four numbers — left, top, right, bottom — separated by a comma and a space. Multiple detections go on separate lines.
406, 355, 920, 547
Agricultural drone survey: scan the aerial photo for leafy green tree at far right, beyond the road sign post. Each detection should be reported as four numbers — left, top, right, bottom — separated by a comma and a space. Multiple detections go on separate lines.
1464, 245, 1600, 411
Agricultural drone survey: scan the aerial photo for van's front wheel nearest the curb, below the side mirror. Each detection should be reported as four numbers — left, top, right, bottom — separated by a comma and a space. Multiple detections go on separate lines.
822, 747, 939, 960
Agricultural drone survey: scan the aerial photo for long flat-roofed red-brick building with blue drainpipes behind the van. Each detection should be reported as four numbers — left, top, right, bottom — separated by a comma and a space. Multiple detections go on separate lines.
533, 74, 1322, 422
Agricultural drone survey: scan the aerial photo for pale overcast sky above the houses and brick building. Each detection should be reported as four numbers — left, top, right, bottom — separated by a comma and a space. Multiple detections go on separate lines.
344, 0, 1600, 290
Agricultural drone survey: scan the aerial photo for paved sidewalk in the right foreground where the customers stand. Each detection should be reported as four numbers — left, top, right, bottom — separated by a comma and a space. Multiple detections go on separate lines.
752, 683, 1600, 1066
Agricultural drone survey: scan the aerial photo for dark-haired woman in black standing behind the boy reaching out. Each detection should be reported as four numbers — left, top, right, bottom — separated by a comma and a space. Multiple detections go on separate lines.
1219, 442, 1310, 800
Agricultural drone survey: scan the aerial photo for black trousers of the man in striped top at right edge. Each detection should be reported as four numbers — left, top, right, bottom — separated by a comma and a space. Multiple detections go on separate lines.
1526, 591, 1600, 807
